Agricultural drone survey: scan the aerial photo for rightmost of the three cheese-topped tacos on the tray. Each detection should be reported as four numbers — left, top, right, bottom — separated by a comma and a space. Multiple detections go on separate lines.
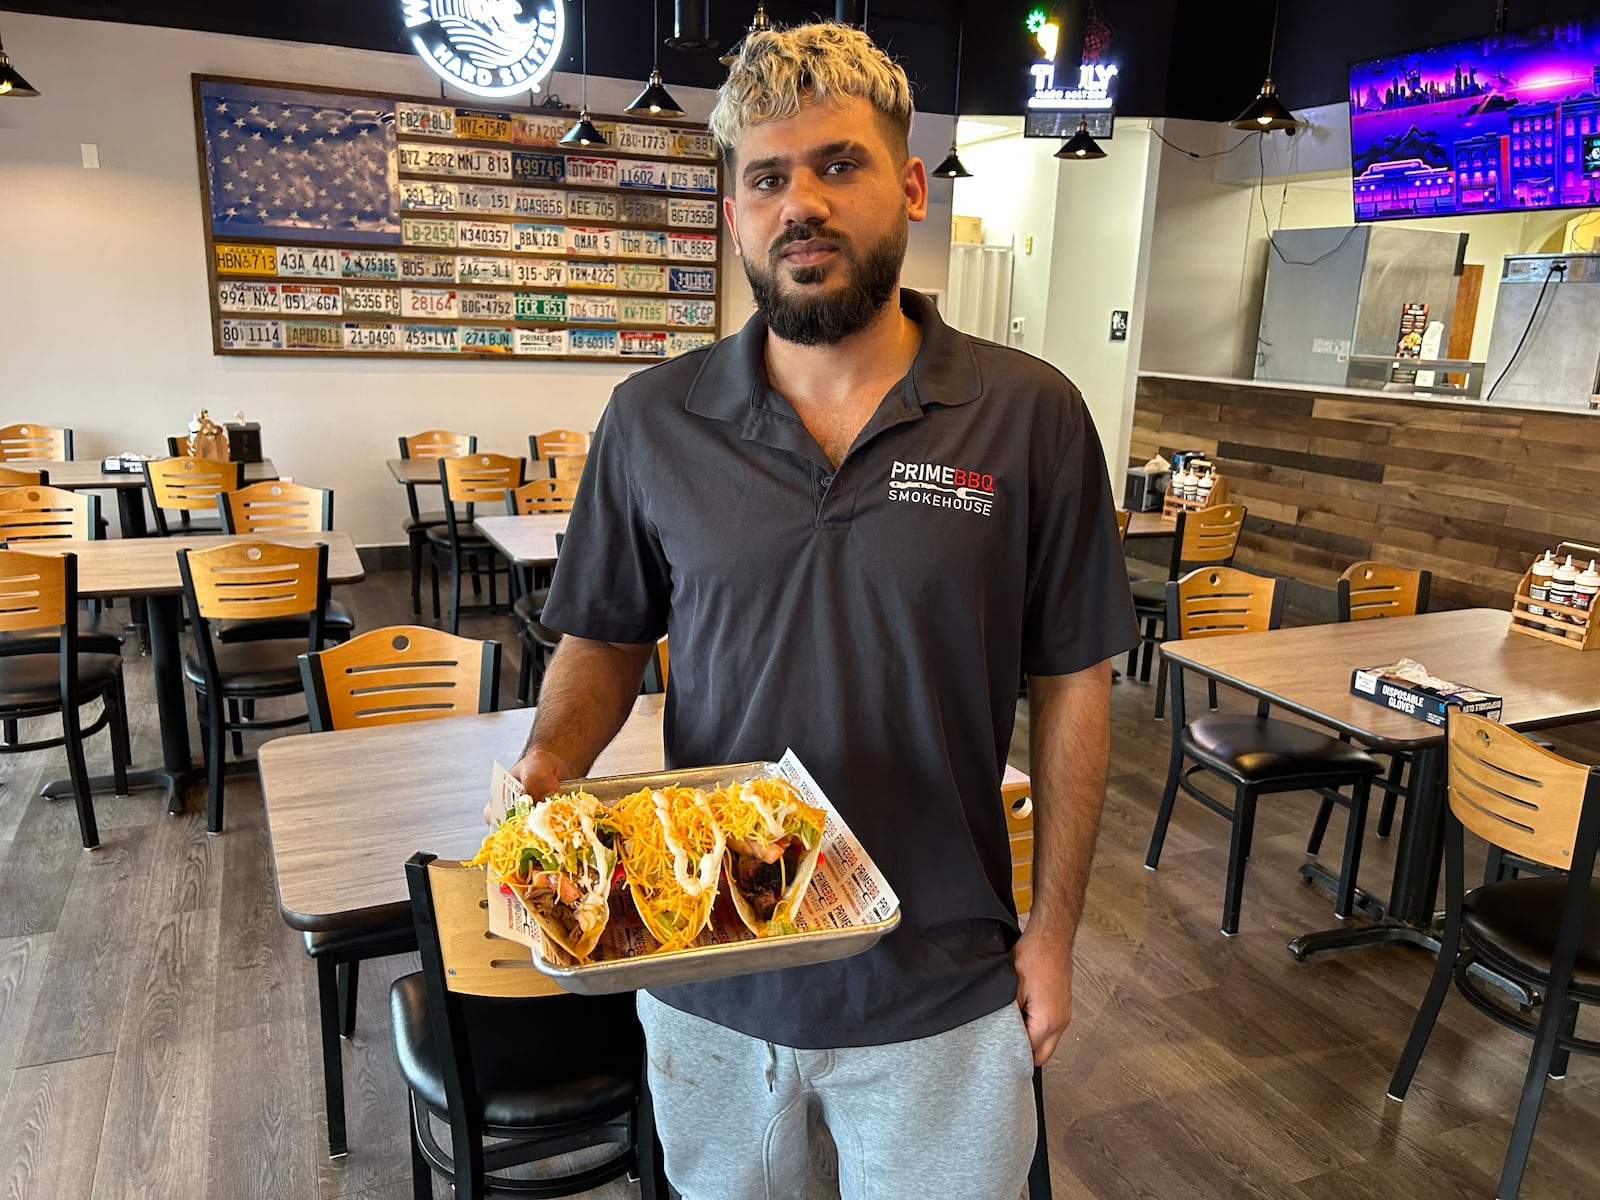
710, 779, 827, 938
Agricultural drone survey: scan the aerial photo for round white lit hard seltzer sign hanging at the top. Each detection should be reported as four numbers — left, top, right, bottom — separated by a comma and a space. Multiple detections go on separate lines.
400, 0, 565, 96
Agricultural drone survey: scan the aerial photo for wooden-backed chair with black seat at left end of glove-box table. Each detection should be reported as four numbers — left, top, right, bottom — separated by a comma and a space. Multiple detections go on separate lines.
1144, 566, 1379, 938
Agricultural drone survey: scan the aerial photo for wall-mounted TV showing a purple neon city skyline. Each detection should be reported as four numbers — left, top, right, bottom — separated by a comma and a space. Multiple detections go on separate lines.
1350, 18, 1600, 221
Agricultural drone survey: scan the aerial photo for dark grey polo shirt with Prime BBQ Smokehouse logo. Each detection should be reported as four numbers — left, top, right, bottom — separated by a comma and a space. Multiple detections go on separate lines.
544, 291, 1138, 1048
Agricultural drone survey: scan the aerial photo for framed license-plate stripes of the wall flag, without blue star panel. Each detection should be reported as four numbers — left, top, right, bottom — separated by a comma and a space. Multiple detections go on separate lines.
192, 74, 725, 363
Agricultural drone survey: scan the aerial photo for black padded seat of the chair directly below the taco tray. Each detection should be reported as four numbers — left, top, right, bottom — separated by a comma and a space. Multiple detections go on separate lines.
389, 972, 645, 1126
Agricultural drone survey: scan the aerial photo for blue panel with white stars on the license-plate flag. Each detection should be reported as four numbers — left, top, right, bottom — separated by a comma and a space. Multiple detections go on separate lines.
200, 80, 400, 245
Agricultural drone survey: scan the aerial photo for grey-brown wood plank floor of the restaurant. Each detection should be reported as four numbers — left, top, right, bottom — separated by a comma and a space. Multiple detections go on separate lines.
0, 573, 1600, 1200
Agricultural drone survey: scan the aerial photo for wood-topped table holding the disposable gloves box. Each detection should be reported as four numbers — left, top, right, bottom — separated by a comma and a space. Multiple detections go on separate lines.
1162, 608, 1600, 958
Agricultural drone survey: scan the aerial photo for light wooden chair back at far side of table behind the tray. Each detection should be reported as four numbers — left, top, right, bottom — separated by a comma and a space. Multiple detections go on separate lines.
299, 626, 501, 733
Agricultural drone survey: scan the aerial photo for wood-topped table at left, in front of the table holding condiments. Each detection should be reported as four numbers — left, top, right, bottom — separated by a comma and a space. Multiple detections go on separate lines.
38, 531, 365, 813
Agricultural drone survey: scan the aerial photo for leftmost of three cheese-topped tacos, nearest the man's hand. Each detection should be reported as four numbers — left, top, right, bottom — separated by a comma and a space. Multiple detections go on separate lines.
467, 790, 616, 963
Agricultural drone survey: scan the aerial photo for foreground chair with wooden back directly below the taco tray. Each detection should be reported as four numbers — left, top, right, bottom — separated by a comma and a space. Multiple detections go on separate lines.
389, 854, 667, 1200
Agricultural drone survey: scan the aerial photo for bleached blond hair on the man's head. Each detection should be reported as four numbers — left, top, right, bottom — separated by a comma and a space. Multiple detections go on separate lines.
710, 22, 912, 163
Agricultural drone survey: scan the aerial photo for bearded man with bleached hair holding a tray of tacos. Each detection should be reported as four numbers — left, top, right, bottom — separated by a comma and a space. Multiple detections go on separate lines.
515, 24, 1138, 1200
